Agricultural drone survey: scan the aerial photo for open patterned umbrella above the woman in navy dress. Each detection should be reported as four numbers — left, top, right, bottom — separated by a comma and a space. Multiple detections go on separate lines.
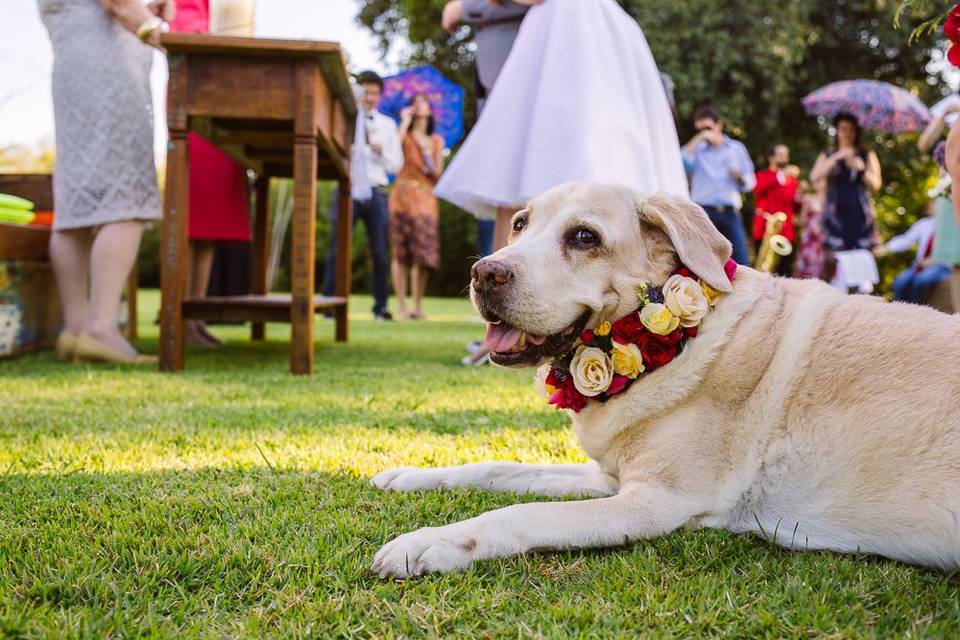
803, 80, 930, 133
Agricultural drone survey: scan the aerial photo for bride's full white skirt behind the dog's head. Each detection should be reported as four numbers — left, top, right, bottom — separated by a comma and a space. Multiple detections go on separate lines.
435, 0, 688, 219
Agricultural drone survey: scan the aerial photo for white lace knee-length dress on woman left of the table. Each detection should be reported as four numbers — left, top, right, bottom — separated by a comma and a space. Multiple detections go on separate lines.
39, 0, 160, 229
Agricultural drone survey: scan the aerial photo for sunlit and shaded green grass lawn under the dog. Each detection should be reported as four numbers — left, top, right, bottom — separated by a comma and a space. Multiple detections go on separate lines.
0, 292, 960, 638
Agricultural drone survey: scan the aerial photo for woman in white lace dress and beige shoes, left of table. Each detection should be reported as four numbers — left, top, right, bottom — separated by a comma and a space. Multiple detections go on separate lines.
38, 0, 174, 364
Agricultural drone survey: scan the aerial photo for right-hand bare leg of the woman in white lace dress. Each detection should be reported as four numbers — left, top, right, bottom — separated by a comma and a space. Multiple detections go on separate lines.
83, 220, 144, 356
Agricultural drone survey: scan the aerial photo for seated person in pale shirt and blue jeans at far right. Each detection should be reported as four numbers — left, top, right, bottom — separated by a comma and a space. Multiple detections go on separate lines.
874, 200, 952, 304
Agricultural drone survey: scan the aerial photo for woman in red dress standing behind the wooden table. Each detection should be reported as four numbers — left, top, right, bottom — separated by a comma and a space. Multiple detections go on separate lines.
170, 0, 251, 348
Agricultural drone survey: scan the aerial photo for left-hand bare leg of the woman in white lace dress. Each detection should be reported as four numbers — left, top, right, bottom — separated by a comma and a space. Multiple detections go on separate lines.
50, 229, 93, 335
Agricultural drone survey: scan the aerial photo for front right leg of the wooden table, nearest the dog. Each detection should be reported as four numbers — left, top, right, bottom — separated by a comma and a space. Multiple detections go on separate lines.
290, 137, 317, 374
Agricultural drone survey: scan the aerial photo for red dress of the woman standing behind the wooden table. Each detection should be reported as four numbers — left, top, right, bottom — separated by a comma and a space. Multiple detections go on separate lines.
170, 0, 250, 242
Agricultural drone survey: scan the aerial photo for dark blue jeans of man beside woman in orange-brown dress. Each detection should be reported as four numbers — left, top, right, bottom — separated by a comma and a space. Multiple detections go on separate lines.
323, 188, 390, 314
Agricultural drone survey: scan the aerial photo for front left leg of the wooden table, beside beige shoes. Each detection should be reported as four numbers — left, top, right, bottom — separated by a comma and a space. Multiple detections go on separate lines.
160, 131, 190, 371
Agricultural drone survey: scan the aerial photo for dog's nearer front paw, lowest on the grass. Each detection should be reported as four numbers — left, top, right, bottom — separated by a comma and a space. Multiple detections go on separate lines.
371, 527, 477, 580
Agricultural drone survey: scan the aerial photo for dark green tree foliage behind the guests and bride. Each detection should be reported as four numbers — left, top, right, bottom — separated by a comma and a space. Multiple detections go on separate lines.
358, 0, 947, 296
